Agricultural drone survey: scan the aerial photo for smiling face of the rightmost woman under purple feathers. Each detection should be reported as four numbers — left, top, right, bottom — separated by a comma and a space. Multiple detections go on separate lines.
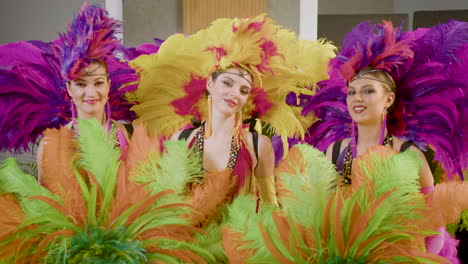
346, 77, 395, 125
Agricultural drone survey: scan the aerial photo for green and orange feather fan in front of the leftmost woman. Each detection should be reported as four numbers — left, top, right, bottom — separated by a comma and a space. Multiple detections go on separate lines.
0, 120, 212, 263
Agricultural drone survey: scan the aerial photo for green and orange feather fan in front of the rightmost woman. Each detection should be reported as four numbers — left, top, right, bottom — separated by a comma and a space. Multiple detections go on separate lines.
223, 145, 468, 263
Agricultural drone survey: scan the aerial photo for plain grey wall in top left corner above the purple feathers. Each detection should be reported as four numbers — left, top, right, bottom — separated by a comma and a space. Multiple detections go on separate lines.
0, 0, 105, 44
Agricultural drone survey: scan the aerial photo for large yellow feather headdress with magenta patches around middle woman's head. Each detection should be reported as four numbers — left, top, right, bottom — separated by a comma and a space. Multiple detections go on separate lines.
126, 15, 335, 139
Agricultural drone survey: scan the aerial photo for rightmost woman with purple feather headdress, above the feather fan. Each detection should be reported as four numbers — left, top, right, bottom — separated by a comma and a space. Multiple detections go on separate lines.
282, 21, 468, 263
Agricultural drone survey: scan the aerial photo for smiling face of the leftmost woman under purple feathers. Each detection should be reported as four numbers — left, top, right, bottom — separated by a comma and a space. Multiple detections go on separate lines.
67, 62, 110, 119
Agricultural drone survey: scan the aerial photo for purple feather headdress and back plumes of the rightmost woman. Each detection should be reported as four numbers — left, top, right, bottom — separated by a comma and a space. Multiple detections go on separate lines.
303, 21, 468, 176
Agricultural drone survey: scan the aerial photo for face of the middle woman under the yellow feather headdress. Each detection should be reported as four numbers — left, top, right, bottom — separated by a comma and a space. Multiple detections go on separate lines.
207, 68, 252, 115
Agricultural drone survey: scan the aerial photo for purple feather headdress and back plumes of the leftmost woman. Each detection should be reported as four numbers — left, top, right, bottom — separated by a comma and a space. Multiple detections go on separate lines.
0, 4, 137, 152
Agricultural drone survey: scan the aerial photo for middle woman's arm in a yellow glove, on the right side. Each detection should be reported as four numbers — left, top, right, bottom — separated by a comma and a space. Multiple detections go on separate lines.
255, 135, 278, 205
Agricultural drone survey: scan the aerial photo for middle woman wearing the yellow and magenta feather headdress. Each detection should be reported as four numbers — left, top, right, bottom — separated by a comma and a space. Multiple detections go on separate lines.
129, 15, 335, 226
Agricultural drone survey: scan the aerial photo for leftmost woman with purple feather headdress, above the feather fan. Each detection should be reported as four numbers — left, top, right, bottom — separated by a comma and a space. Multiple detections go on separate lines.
0, 3, 137, 177
